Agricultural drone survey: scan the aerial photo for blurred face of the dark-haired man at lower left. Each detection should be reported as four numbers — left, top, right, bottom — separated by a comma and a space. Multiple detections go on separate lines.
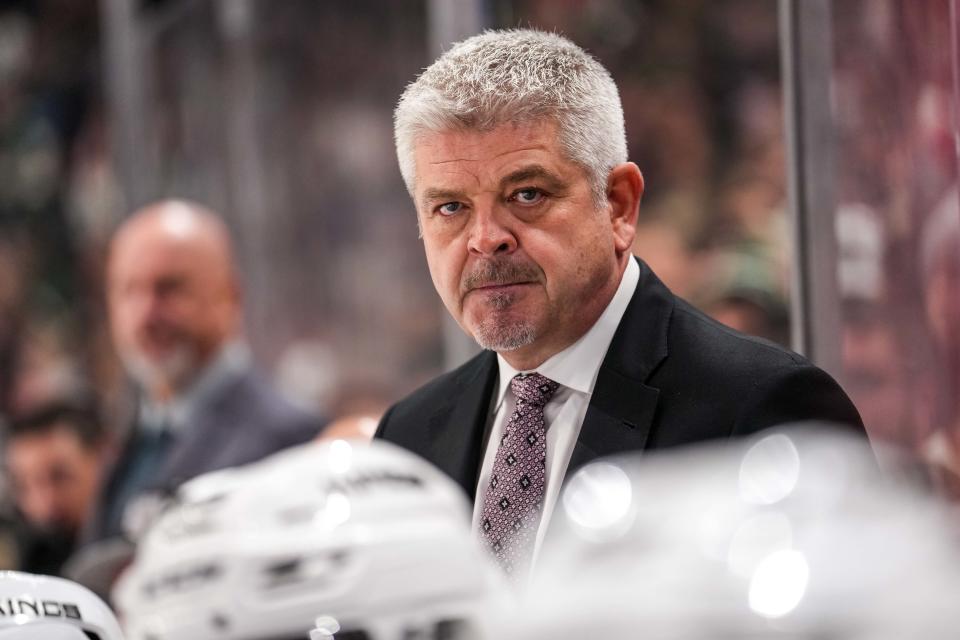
6, 427, 100, 535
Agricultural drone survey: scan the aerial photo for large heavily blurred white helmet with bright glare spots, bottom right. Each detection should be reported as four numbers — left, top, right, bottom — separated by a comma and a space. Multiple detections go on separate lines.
498, 427, 960, 640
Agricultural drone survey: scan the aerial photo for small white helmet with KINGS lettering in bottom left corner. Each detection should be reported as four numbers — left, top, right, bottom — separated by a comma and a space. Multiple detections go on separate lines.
0, 571, 123, 640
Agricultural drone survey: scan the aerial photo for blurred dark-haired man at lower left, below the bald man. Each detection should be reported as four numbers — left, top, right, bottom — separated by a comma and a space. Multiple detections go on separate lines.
4, 404, 105, 575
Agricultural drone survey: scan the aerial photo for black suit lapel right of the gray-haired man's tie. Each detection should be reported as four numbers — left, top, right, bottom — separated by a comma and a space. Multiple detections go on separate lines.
566, 260, 674, 477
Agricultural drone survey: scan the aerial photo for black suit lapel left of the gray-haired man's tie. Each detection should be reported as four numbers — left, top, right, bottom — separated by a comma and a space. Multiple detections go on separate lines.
426, 351, 497, 501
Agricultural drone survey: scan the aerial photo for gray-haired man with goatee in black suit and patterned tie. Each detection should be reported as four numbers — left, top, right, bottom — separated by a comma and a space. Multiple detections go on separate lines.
378, 30, 863, 574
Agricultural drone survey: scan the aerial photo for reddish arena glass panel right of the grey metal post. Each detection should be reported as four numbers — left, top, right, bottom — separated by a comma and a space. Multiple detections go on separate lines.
799, 0, 960, 497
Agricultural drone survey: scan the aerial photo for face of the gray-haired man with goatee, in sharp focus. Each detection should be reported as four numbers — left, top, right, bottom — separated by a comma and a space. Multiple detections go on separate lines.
414, 121, 642, 368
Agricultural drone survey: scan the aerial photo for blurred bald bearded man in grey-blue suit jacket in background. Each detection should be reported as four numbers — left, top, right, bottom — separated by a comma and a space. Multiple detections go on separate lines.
79, 201, 321, 552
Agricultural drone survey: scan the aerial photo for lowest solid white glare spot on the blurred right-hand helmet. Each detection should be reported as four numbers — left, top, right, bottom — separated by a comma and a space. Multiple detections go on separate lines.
748, 549, 810, 618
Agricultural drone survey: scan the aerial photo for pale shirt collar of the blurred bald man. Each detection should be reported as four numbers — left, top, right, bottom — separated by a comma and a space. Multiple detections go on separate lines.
140, 341, 251, 431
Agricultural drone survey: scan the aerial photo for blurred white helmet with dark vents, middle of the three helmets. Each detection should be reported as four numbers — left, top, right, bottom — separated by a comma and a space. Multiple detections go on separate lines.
114, 440, 495, 640
